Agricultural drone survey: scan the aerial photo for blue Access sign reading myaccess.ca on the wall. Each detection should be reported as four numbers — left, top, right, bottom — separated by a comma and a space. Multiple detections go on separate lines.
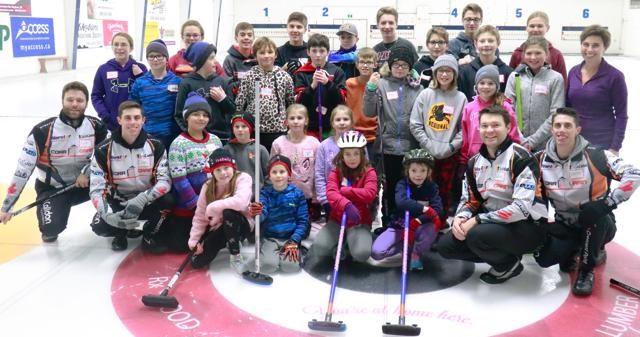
11, 16, 56, 57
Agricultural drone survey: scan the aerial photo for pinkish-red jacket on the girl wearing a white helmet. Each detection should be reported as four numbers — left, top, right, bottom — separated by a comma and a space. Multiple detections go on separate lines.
327, 167, 378, 226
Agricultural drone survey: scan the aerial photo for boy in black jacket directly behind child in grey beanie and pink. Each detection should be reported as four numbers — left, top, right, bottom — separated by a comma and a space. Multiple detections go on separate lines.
458, 25, 513, 100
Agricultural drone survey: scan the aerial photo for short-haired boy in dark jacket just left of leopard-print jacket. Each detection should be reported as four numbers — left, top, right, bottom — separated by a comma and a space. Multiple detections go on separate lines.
222, 22, 257, 97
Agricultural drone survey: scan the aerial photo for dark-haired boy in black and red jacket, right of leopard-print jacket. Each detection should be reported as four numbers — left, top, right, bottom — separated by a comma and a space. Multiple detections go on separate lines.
295, 34, 347, 141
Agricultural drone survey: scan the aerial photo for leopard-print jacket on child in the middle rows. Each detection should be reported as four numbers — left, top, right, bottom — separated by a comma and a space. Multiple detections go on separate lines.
236, 66, 295, 133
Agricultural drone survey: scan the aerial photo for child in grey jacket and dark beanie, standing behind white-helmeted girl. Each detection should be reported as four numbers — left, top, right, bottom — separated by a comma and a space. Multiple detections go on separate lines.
364, 47, 422, 220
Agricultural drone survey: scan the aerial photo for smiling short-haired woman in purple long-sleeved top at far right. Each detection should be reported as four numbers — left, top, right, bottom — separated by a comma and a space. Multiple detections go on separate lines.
566, 25, 627, 155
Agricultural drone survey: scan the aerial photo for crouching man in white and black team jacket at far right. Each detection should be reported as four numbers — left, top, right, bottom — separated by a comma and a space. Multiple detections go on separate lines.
536, 108, 640, 296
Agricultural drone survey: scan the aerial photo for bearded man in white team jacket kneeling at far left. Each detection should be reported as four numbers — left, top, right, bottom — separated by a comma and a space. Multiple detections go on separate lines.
0, 82, 108, 242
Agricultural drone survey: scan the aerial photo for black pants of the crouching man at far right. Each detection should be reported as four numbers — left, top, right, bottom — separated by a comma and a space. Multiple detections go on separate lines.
535, 213, 617, 270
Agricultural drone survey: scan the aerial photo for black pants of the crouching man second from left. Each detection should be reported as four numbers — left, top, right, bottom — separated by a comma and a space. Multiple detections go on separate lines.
91, 193, 175, 238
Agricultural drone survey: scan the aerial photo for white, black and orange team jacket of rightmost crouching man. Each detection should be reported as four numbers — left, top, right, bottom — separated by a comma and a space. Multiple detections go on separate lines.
536, 135, 640, 226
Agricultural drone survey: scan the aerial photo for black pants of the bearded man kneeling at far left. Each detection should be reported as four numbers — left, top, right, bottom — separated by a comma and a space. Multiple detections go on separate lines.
36, 180, 89, 236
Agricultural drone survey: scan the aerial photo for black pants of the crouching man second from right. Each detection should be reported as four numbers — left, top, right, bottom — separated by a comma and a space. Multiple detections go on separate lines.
437, 220, 546, 272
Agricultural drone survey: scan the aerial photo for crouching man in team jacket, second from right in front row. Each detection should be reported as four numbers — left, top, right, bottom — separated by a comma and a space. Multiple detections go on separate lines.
438, 105, 547, 284
